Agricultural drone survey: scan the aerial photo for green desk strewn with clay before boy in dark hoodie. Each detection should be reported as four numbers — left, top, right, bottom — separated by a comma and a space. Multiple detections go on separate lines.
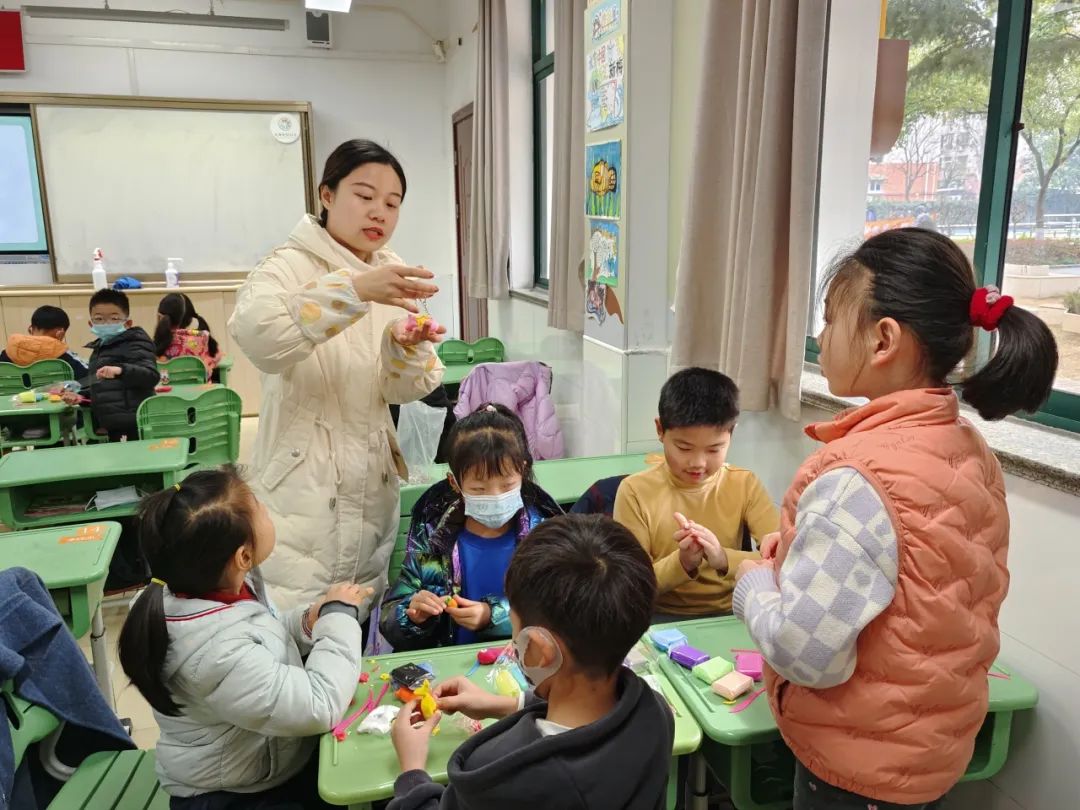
319, 644, 701, 808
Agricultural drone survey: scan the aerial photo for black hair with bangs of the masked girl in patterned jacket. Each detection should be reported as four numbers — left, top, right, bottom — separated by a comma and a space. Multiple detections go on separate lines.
447, 403, 532, 486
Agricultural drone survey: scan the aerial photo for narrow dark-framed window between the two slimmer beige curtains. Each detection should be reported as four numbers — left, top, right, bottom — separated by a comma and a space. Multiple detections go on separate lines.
532, 0, 556, 288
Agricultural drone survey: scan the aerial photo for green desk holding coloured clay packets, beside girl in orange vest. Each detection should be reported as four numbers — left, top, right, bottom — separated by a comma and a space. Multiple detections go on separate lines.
658, 617, 1038, 810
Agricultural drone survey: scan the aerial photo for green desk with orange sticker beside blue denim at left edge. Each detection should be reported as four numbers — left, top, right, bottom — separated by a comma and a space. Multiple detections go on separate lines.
0, 527, 120, 706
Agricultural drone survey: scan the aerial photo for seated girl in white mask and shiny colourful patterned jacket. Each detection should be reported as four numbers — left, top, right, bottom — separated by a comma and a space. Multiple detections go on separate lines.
380, 404, 563, 650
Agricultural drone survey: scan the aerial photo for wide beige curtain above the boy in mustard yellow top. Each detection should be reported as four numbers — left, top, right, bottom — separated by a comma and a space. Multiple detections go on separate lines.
672, 0, 828, 419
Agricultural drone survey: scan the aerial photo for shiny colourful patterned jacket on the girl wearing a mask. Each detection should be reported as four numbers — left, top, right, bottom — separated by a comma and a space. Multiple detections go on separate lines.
379, 481, 563, 650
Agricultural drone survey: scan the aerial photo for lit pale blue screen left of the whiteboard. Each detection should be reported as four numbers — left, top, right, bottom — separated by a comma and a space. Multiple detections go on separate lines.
0, 114, 49, 254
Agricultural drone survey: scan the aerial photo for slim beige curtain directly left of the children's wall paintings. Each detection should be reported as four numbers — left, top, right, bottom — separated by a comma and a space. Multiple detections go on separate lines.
548, 0, 586, 332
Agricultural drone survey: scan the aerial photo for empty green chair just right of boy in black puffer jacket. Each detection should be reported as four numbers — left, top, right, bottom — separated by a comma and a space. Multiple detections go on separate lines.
135, 386, 242, 468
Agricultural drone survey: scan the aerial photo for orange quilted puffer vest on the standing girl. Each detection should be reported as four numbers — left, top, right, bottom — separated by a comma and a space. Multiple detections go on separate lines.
766, 389, 1009, 805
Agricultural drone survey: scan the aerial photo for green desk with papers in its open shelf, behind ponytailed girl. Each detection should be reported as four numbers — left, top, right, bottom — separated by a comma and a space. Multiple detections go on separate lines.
0, 440, 188, 529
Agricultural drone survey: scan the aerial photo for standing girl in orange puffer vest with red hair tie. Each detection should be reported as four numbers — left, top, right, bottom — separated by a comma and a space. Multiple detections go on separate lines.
734, 228, 1057, 810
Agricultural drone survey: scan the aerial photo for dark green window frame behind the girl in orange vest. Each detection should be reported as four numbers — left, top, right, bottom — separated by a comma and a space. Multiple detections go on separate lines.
806, 0, 1080, 433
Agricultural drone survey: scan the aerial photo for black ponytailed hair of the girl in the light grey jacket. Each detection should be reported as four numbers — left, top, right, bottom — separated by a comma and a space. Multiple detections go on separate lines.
119, 465, 255, 716
